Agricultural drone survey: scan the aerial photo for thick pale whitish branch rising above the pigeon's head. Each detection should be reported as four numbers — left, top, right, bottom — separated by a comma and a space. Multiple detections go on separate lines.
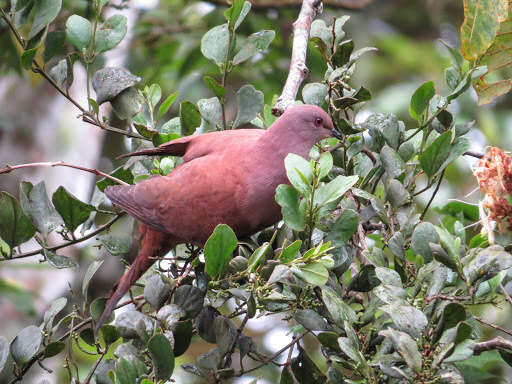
272, 0, 322, 116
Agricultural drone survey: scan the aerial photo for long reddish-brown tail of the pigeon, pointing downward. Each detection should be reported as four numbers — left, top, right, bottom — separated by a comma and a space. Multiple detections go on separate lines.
94, 224, 179, 334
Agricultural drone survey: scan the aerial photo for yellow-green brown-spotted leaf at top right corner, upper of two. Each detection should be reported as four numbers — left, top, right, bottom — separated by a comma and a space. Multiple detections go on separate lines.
460, 0, 508, 61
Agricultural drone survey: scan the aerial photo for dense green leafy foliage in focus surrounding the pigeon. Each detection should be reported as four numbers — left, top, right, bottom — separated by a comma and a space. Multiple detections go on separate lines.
0, 0, 512, 384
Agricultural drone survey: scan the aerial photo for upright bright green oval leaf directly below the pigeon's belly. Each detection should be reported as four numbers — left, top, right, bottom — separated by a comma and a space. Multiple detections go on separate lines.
204, 224, 238, 279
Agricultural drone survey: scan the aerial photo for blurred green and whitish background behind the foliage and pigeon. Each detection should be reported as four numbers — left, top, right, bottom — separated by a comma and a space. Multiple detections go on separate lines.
0, 0, 512, 383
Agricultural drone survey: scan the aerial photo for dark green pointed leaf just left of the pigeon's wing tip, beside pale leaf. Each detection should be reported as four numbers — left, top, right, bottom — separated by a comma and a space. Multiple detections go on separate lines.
52, 187, 96, 232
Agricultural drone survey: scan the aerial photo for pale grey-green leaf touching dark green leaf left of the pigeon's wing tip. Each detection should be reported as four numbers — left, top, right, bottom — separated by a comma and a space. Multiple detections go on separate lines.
20, 181, 64, 237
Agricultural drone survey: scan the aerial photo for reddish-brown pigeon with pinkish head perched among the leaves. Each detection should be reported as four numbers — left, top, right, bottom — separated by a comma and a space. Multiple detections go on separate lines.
95, 104, 342, 332
